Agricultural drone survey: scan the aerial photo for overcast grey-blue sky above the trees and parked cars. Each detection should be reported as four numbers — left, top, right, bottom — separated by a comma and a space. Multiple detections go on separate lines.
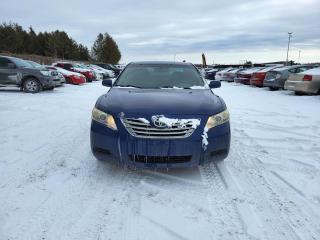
0, 0, 320, 63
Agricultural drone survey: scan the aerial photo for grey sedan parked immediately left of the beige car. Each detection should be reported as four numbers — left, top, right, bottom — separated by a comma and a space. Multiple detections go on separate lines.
263, 65, 316, 90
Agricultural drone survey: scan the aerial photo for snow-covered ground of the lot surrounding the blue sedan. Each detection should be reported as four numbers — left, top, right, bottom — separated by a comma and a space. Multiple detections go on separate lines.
0, 82, 320, 240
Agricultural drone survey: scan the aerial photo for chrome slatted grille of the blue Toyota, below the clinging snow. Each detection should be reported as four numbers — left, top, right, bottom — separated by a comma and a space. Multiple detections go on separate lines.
122, 118, 195, 138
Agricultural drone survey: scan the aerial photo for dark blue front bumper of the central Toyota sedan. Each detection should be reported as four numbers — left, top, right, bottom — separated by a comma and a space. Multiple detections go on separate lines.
91, 121, 230, 169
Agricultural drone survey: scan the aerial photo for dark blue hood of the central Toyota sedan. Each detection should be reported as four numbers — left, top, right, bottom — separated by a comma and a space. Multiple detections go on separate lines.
96, 87, 226, 116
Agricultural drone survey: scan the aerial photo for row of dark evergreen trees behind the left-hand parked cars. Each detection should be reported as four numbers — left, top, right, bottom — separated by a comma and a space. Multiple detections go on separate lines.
0, 23, 121, 64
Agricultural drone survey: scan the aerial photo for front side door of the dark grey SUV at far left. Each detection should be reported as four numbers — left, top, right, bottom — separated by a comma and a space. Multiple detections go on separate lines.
0, 57, 21, 85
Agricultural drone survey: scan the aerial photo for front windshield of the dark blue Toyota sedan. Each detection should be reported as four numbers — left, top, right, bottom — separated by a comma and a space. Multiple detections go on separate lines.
115, 64, 204, 89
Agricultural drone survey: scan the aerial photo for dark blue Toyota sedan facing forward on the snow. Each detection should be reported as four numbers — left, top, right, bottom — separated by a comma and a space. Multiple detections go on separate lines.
91, 62, 230, 168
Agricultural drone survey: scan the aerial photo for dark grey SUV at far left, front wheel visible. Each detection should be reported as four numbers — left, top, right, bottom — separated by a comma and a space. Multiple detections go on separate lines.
0, 55, 55, 93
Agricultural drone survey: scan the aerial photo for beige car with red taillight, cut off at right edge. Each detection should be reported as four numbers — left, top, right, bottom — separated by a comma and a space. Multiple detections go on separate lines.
284, 67, 320, 95
